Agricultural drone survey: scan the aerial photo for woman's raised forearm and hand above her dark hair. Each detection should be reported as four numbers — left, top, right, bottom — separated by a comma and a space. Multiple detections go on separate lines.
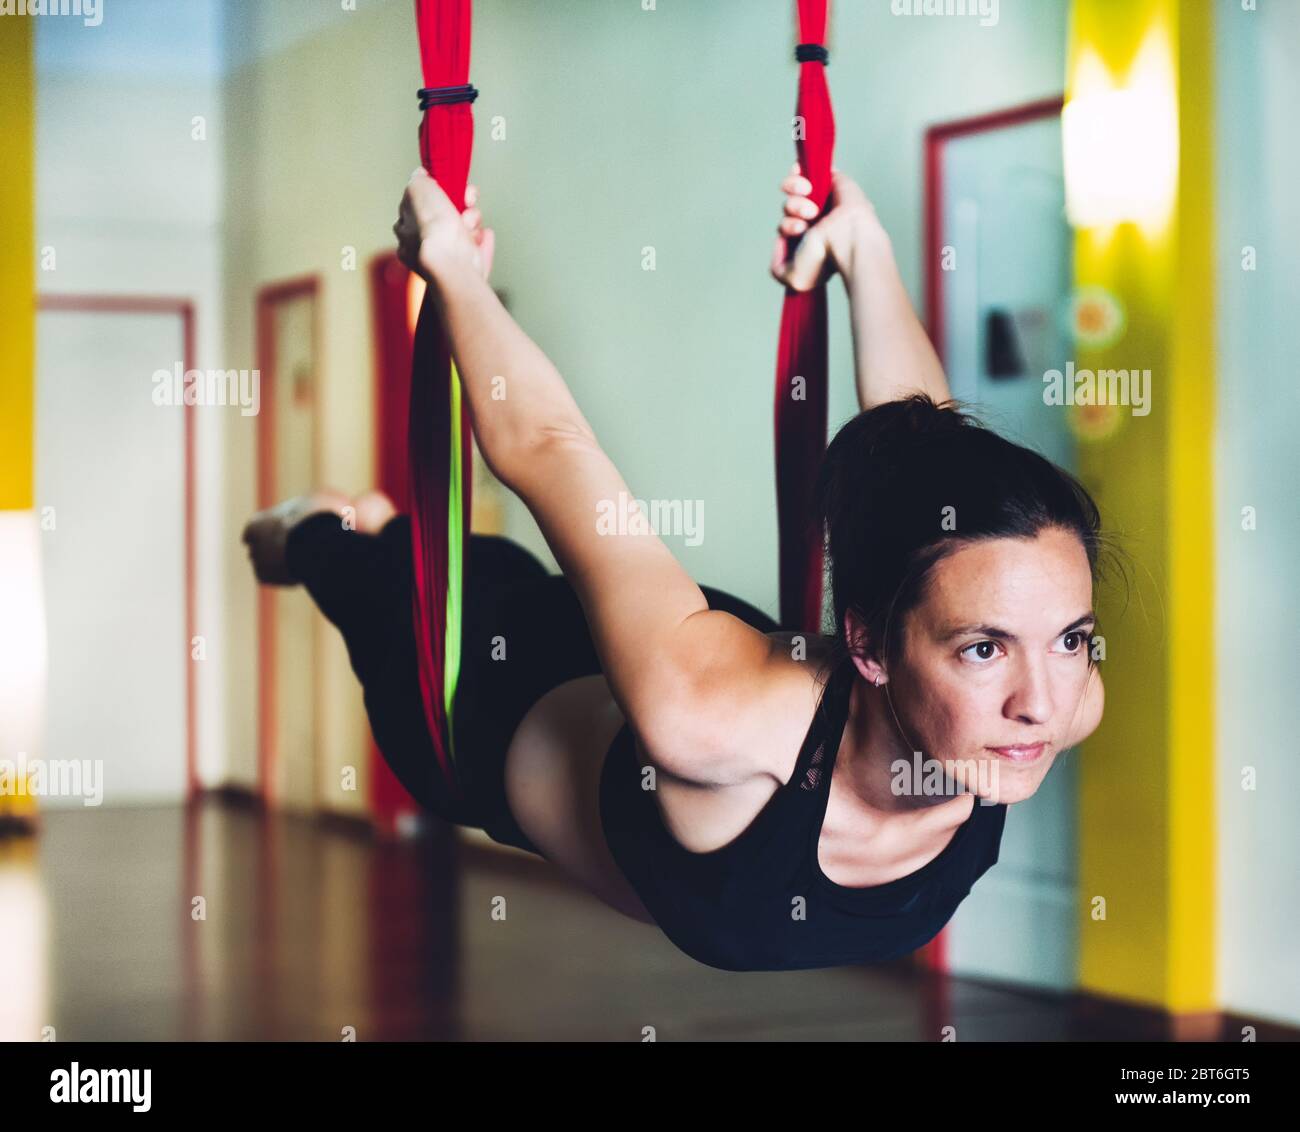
772, 164, 952, 409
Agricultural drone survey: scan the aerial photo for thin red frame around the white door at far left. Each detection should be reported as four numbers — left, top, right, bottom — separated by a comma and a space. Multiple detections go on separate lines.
36, 295, 199, 803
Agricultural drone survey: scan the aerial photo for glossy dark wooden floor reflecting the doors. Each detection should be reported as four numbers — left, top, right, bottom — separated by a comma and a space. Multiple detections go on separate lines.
0, 799, 1289, 1041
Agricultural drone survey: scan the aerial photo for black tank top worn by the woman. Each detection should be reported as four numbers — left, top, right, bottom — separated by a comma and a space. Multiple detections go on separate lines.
601, 662, 1006, 971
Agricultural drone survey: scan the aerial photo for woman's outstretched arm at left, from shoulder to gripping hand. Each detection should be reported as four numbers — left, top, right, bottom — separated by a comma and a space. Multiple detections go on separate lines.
395, 172, 776, 785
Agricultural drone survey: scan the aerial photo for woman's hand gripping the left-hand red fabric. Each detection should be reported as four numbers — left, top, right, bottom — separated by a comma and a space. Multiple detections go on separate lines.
393, 169, 495, 283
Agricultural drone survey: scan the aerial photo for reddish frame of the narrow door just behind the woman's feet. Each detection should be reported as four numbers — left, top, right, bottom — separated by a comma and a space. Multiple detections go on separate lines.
254, 274, 322, 807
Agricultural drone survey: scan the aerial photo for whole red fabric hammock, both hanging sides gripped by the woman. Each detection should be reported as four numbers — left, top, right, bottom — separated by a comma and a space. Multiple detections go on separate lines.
408, 0, 835, 797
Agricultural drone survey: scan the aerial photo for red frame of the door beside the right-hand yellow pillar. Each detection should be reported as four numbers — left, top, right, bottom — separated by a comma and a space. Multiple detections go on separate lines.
917, 95, 1065, 982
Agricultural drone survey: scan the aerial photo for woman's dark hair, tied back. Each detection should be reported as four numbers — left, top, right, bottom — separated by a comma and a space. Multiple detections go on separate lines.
816, 394, 1110, 668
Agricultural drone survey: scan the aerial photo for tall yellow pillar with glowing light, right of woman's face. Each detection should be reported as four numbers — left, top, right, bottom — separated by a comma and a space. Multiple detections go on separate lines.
1067, 0, 1216, 1012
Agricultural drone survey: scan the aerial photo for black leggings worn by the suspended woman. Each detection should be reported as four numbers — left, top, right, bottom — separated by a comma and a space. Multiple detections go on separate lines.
286, 512, 777, 856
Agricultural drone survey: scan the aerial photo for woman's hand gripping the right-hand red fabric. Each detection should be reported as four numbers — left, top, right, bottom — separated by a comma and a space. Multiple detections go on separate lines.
771, 161, 881, 291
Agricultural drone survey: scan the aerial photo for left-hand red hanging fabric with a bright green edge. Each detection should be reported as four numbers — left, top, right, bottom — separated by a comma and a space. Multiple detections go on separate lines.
408, 0, 475, 798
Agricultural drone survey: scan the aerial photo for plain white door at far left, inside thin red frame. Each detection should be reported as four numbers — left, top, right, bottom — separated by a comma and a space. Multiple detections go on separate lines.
35, 311, 187, 807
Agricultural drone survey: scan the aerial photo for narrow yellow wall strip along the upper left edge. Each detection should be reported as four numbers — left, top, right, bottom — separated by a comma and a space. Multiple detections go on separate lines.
0, 18, 36, 511
